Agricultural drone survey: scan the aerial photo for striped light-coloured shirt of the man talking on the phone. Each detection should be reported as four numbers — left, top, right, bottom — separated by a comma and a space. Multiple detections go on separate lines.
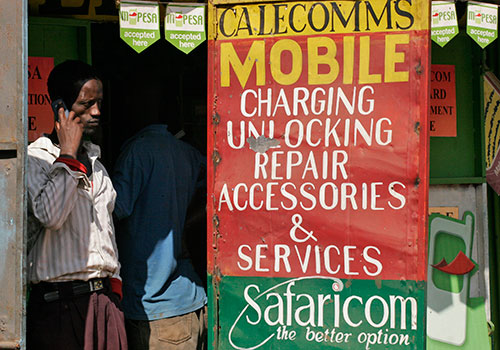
27, 137, 120, 283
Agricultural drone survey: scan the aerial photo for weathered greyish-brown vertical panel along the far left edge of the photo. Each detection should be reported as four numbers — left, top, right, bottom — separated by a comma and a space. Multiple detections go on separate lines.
0, 0, 28, 349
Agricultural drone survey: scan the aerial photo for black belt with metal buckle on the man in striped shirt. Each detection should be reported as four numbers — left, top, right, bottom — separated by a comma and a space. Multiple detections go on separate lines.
32, 278, 110, 302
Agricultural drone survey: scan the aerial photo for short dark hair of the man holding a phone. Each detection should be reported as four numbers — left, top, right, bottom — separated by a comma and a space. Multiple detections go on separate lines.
47, 60, 101, 109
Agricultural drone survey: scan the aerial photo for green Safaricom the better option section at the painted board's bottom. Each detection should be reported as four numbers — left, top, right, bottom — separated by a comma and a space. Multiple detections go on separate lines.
209, 276, 425, 350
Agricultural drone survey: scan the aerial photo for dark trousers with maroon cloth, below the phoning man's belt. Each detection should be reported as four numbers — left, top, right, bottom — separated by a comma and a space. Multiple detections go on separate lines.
26, 282, 127, 350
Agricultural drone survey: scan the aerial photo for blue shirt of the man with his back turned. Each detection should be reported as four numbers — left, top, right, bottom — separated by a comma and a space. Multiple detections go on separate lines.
113, 125, 207, 320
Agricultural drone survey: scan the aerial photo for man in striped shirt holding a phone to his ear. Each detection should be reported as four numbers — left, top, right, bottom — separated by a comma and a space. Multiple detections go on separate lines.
27, 61, 127, 350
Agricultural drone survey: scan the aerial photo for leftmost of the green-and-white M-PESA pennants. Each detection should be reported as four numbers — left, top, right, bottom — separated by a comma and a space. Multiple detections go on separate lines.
120, 2, 160, 53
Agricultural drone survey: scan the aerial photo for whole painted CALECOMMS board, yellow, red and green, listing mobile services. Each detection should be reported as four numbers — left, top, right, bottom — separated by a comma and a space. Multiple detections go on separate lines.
208, 0, 430, 349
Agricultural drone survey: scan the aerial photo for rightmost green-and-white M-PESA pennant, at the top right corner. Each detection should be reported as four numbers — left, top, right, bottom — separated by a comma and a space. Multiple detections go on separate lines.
467, 1, 498, 49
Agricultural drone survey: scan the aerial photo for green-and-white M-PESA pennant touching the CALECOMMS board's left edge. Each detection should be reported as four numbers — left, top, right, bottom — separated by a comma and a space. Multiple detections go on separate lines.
165, 4, 206, 54
